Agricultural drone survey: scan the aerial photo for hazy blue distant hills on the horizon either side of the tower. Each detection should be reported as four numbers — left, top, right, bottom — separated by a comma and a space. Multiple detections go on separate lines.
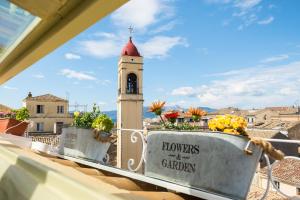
103, 105, 216, 122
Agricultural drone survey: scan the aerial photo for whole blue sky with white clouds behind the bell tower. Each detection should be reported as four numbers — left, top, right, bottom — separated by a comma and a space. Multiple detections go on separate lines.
0, 0, 300, 110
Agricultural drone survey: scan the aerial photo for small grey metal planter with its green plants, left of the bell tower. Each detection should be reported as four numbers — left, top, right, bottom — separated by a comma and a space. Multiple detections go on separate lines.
59, 105, 113, 162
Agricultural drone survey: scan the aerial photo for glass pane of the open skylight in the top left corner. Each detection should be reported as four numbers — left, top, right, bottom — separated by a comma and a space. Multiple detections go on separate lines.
0, 0, 40, 61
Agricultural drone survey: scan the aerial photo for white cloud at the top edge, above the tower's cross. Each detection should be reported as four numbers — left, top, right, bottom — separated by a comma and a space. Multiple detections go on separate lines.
111, 0, 174, 29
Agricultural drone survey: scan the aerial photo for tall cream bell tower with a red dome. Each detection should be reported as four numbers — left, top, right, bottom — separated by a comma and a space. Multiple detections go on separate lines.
117, 36, 144, 169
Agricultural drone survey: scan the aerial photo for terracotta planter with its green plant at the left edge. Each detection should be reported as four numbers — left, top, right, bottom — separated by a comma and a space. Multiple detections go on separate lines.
0, 107, 29, 136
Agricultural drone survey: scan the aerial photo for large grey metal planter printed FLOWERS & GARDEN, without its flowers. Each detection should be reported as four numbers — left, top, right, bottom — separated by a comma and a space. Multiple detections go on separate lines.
145, 131, 262, 199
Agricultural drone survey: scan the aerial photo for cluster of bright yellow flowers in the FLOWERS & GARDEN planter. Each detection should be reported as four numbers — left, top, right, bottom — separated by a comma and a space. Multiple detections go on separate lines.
208, 115, 247, 136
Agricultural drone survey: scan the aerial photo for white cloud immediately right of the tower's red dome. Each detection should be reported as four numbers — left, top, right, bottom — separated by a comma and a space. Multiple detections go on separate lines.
139, 36, 188, 58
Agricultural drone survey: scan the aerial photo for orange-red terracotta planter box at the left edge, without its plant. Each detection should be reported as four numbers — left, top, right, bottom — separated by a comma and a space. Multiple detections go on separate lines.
0, 119, 28, 136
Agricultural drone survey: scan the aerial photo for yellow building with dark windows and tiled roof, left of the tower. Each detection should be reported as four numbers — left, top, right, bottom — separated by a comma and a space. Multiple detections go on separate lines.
23, 93, 73, 134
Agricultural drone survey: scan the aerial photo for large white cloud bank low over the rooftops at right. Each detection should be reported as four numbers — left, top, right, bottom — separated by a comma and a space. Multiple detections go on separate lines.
172, 62, 300, 108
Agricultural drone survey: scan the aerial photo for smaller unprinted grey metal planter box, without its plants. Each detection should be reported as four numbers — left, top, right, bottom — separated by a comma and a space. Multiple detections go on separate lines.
59, 127, 110, 163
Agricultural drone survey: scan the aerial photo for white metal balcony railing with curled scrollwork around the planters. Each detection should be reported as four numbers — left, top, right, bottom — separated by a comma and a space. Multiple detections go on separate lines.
1, 129, 300, 200
